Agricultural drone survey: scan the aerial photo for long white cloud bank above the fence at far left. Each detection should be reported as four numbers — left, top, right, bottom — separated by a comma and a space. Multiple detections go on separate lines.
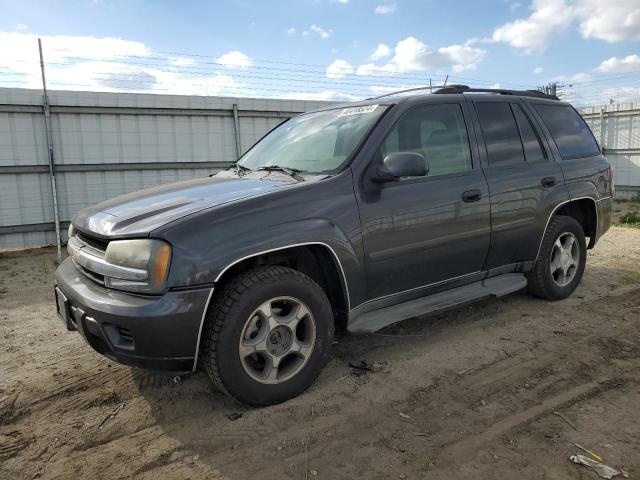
0, 32, 248, 95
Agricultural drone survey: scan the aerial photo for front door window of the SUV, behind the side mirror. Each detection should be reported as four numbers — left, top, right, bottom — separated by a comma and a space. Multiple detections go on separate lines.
380, 103, 472, 176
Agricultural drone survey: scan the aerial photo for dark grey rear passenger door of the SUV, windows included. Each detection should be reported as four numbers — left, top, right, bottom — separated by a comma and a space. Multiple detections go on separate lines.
469, 96, 569, 273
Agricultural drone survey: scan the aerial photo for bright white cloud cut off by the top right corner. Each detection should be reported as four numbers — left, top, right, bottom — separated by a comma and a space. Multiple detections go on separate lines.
489, 0, 640, 53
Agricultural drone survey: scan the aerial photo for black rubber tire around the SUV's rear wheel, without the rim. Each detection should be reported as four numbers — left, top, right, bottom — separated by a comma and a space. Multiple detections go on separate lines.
527, 215, 587, 300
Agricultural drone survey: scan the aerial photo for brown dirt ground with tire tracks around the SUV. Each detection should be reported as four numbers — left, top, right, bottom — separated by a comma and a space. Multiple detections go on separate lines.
0, 227, 640, 480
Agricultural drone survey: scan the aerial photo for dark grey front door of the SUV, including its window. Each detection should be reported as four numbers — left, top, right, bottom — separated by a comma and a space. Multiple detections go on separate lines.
358, 102, 490, 304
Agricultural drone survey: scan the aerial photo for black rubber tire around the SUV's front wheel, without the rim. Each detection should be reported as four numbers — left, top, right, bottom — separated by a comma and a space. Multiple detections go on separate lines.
202, 266, 334, 406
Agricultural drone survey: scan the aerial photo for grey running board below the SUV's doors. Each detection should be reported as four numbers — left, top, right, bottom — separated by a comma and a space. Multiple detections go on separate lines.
347, 273, 527, 333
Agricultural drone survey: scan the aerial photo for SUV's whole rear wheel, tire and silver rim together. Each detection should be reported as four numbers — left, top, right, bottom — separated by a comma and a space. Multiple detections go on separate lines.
527, 215, 587, 300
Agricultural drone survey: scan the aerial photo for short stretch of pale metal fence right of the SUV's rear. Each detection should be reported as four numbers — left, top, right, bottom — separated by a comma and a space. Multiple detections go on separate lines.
581, 102, 640, 197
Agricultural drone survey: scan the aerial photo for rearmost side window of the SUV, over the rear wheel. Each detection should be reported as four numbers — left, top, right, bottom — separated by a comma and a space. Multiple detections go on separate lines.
534, 104, 600, 159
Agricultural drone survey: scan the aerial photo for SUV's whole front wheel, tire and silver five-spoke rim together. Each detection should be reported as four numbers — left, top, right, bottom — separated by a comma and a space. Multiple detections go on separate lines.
203, 266, 333, 405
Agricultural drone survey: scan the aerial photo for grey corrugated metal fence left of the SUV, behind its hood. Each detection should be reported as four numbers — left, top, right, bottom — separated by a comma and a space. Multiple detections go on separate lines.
0, 89, 336, 249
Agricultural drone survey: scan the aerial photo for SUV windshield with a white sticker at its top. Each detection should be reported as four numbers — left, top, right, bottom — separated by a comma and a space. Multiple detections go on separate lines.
238, 105, 386, 173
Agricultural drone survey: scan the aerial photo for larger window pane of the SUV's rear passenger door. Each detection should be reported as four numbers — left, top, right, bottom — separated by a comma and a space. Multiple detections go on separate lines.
476, 102, 524, 167
